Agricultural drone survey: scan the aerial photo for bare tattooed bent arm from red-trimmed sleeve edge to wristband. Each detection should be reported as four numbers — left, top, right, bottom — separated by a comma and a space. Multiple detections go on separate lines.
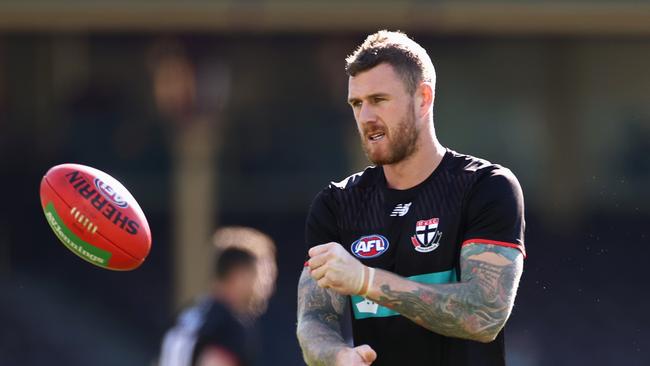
372, 244, 523, 342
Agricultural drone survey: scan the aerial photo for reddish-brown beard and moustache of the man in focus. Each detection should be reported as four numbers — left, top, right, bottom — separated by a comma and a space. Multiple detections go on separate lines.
361, 108, 420, 165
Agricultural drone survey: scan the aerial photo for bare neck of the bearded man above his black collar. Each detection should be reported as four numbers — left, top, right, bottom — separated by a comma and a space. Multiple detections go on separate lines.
383, 131, 445, 190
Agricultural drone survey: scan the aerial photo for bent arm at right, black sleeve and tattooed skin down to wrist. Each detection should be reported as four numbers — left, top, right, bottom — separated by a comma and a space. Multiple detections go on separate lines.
368, 167, 526, 342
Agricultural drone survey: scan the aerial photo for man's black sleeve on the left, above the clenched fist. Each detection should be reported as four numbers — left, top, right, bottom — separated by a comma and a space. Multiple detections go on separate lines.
305, 188, 340, 250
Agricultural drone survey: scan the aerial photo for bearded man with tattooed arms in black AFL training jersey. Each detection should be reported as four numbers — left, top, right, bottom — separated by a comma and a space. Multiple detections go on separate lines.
297, 31, 525, 366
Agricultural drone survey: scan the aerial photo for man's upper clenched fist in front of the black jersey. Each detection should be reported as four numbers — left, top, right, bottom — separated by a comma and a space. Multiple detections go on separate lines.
307, 242, 368, 295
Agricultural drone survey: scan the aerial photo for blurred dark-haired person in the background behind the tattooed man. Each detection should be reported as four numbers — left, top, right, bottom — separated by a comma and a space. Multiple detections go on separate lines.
159, 227, 277, 366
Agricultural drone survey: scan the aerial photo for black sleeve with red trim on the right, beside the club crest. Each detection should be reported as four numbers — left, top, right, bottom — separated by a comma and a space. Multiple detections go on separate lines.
462, 168, 526, 257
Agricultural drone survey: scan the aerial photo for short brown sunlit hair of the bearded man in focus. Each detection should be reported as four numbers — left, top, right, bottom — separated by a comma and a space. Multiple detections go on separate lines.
345, 30, 436, 93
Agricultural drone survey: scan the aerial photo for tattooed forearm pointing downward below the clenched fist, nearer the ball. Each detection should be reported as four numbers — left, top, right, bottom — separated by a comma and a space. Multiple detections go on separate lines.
297, 269, 347, 366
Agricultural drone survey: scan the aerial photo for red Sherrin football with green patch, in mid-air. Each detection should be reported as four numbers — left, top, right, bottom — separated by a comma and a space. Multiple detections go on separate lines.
41, 164, 151, 271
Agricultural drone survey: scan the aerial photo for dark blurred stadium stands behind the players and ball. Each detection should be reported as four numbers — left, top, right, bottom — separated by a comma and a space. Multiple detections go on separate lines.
0, 0, 650, 366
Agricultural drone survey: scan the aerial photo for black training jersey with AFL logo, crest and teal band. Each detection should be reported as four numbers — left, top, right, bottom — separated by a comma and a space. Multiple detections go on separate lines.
306, 150, 525, 366
